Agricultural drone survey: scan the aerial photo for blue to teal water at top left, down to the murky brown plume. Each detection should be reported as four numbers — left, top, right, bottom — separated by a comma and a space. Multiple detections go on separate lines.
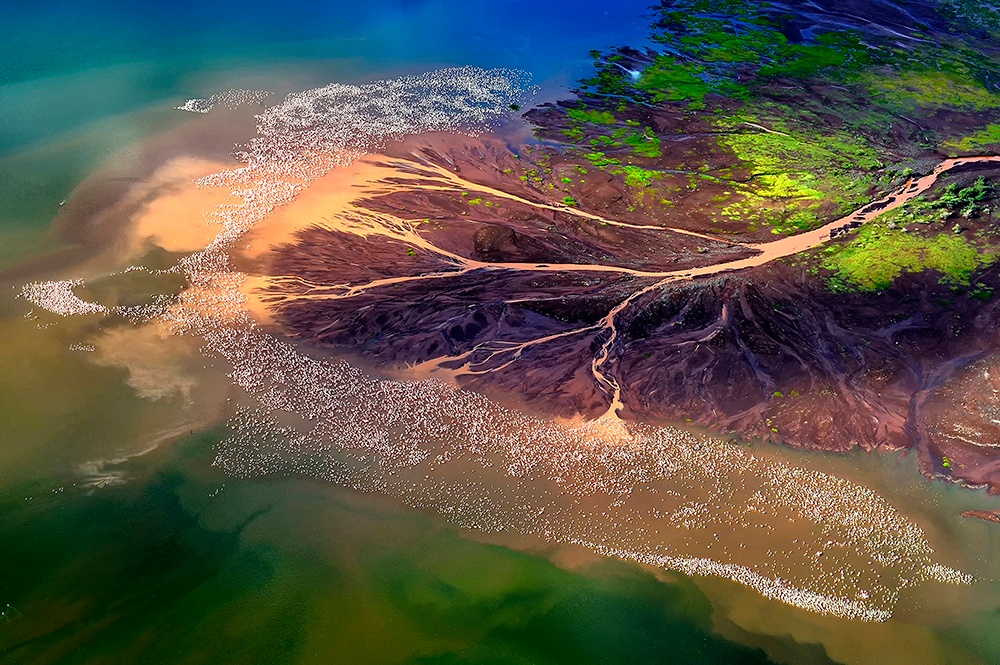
0, 0, 649, 271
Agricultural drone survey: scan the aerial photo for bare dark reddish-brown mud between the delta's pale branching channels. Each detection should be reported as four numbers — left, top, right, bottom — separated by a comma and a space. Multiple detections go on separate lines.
250, 128, 1000, 491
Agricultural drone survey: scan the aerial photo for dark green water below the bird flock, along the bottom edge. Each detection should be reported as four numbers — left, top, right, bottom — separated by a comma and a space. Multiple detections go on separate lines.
0, 431, 804, 663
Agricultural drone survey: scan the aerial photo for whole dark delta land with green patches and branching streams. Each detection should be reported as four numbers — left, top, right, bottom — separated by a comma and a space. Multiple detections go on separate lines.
241, 2, 1000, 491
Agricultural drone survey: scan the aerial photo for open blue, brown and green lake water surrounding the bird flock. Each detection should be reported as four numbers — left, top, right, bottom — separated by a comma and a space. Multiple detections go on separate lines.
0, 3, 1000, 664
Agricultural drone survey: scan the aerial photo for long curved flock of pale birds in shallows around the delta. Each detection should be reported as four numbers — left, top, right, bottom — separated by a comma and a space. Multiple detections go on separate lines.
24, 67, 971, 621
